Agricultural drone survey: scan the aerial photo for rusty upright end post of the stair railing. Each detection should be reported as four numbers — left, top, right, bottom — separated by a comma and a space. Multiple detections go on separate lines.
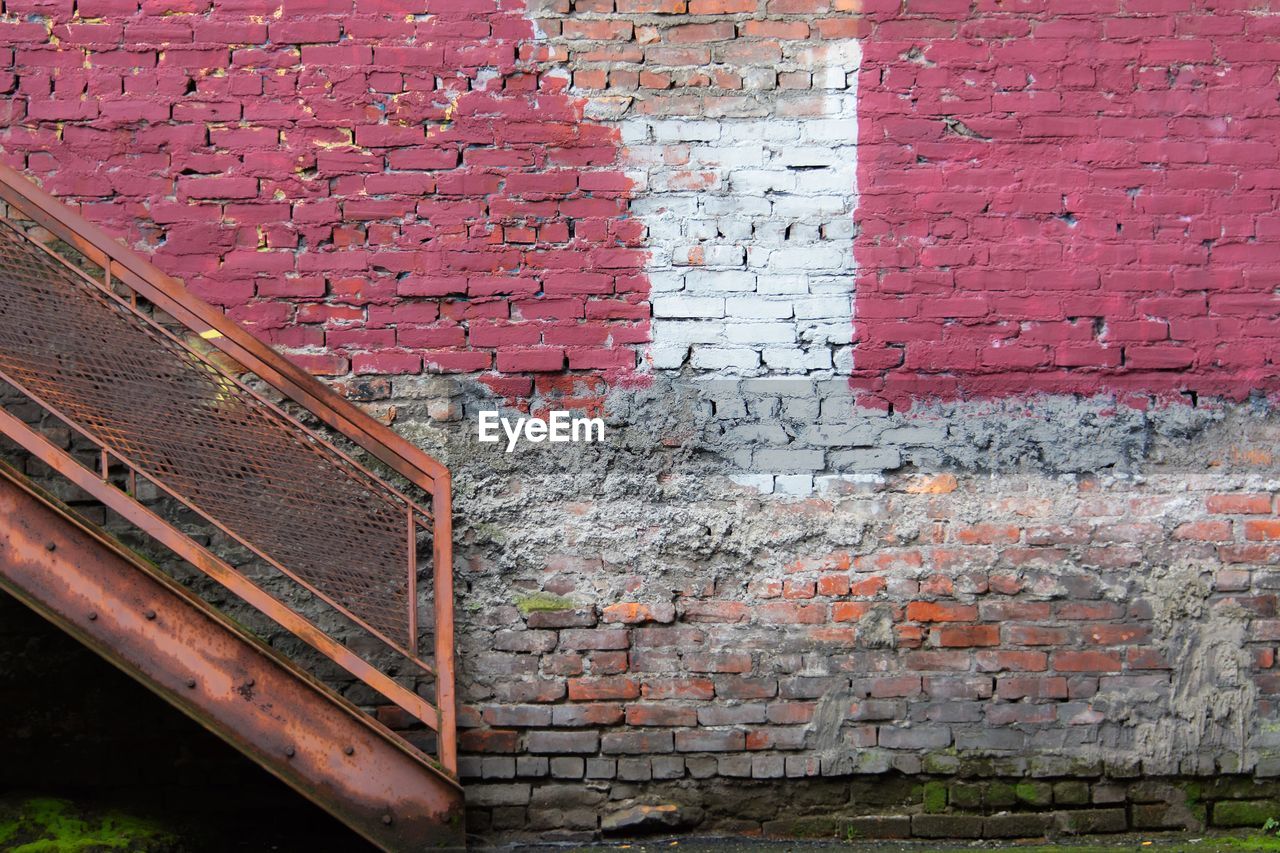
431, 476, 458, 774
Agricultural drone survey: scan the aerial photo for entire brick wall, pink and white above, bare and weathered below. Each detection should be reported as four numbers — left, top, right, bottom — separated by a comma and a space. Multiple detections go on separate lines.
0, 0, 1280, 836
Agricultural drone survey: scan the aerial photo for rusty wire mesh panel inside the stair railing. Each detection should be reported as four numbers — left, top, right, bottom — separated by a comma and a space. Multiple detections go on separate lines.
0, 222, 416, 652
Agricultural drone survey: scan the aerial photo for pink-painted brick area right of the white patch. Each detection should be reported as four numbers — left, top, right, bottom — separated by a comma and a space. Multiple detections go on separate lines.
851, 0, 1280, 407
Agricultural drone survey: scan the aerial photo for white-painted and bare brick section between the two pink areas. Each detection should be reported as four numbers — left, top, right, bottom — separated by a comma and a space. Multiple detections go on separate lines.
535, 1, 861, 377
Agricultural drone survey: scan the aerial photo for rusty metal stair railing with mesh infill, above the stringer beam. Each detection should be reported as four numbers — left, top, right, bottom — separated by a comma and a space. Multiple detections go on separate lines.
0, 167, 457, 774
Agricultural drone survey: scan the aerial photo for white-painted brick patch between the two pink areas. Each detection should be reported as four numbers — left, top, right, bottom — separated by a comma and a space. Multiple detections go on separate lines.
621, 40, 861, 375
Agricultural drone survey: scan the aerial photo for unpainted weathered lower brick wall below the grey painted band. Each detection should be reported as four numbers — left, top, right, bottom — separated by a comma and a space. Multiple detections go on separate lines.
437, 424, 1280, 836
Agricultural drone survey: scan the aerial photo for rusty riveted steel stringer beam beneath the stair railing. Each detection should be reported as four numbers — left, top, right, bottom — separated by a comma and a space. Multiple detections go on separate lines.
0, 465, 465, 853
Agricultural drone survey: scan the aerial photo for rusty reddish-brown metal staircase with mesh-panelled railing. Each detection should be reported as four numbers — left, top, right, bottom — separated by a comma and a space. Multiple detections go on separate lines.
0, 167, 463, 850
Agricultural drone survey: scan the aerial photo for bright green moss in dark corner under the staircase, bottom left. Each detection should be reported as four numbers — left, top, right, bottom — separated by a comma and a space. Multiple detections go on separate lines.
0, 798, 178, 853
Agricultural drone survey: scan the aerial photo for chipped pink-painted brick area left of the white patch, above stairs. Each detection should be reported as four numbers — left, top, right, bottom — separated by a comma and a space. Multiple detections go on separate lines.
0, 0, 649, 397
